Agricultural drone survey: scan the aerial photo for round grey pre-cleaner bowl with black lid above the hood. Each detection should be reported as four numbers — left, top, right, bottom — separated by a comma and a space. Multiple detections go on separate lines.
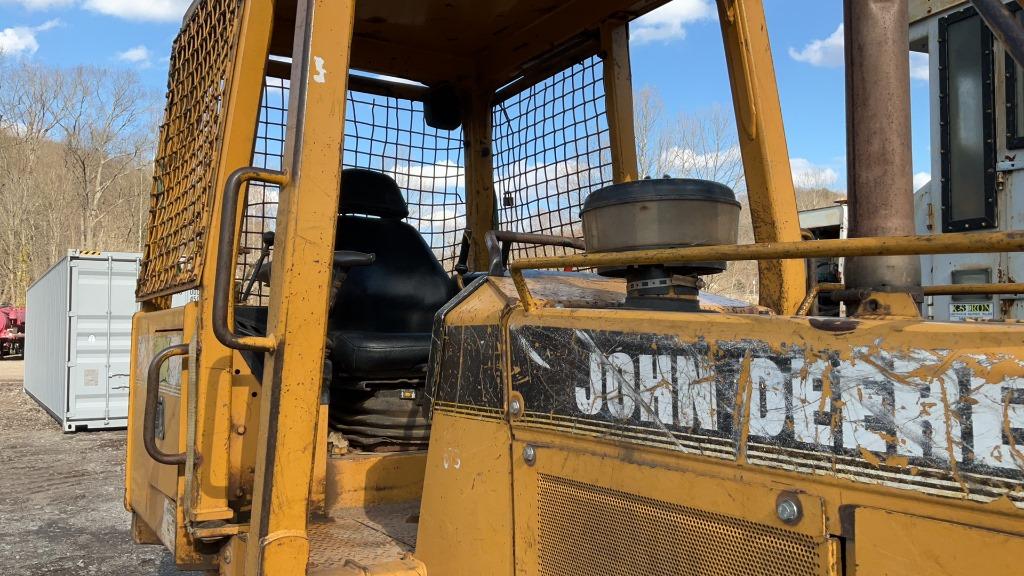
583, 178, 740, 276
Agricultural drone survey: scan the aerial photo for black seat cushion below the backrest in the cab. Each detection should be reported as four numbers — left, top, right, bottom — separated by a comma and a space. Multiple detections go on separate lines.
331, 330, 430, 379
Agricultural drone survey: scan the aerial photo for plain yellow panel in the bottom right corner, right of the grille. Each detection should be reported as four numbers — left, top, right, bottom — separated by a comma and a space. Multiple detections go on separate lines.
854, 508, 1024, 576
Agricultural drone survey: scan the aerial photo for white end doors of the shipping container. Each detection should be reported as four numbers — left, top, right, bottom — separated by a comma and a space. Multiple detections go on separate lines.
68, 258, 138, 427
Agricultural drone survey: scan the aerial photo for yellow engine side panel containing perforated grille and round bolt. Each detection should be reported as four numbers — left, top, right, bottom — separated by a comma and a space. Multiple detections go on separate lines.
507, 426, 834, 576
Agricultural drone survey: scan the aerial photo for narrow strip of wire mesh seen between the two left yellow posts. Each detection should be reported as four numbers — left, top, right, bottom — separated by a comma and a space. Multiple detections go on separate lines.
236, 77, 290, 305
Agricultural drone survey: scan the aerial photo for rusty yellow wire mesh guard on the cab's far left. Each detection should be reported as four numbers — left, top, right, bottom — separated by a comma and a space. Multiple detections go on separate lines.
137, 0, 242, 299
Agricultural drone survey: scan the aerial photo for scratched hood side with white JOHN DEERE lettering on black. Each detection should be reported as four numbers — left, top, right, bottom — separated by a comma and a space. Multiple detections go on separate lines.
509, 313, 1024, 507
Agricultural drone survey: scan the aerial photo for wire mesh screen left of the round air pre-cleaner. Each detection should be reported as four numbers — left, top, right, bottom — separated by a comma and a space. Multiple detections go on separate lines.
494, 56, 613, 257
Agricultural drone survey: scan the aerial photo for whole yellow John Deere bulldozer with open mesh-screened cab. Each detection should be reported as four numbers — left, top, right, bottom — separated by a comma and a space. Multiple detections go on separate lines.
125, 0, 1024, 576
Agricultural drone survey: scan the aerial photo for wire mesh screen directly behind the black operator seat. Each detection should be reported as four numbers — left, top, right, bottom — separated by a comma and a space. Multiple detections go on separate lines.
343, 91, 466, 272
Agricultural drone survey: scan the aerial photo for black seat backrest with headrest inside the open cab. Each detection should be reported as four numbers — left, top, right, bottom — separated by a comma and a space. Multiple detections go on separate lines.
331, 169, 454, 333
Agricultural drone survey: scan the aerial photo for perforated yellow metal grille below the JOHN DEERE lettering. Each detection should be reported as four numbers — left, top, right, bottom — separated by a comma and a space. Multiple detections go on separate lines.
538, 475, 827, 576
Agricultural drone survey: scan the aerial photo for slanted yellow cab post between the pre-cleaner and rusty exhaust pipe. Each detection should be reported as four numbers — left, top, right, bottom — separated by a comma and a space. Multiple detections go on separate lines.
718, 0, 807, 314
